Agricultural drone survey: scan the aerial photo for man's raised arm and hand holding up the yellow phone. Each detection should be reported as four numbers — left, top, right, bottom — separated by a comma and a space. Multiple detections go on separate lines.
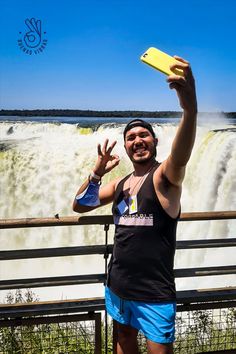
162, 56, 197, 186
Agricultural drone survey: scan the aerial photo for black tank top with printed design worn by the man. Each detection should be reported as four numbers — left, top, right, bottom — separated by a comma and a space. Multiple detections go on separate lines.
107, 166, 178, 302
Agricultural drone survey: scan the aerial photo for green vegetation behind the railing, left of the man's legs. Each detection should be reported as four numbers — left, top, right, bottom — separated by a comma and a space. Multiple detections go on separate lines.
0, 290, 95, 354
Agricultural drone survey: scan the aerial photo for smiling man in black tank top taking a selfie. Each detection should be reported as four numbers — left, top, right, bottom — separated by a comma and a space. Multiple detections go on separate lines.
73, 57, 197, 354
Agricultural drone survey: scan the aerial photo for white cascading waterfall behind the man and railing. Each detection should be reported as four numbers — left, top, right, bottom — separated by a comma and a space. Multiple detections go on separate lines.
0, 121, 236, 299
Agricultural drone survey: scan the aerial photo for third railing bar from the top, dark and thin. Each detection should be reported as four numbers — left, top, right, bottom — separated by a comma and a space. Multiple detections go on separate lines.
0, 265, 236, 290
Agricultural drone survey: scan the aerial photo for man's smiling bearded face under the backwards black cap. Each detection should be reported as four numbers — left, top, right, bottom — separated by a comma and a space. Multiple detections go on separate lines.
125, 127, 157, 164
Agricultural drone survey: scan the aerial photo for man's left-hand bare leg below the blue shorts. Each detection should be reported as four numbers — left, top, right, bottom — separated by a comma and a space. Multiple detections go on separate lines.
116, 322, 138, 354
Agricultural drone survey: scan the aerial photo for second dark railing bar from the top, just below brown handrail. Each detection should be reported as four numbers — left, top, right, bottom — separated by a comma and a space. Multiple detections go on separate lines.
0, 238, 236, 261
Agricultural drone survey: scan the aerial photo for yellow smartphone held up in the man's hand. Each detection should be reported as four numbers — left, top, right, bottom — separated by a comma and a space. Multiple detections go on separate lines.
140, 47, 184, 76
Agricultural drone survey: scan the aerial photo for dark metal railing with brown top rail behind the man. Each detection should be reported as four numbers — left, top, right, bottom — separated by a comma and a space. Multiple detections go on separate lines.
0, 211, 236, 354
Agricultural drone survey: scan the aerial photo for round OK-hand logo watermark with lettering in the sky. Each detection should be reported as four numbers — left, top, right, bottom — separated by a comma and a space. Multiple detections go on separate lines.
17, 18, 48, 55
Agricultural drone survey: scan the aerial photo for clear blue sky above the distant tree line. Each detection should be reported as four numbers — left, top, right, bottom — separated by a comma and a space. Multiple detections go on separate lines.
0, 0, 236, 112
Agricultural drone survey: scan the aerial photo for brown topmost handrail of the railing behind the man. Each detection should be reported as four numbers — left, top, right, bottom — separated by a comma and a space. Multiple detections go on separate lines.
0, 211, 236, 229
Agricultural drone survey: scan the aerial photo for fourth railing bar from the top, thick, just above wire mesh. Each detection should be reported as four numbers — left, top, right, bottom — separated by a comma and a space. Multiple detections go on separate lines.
0, 287, 236, 318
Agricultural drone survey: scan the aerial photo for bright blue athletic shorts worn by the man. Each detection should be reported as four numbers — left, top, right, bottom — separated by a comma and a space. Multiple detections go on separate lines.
105, 287, 176, 344
